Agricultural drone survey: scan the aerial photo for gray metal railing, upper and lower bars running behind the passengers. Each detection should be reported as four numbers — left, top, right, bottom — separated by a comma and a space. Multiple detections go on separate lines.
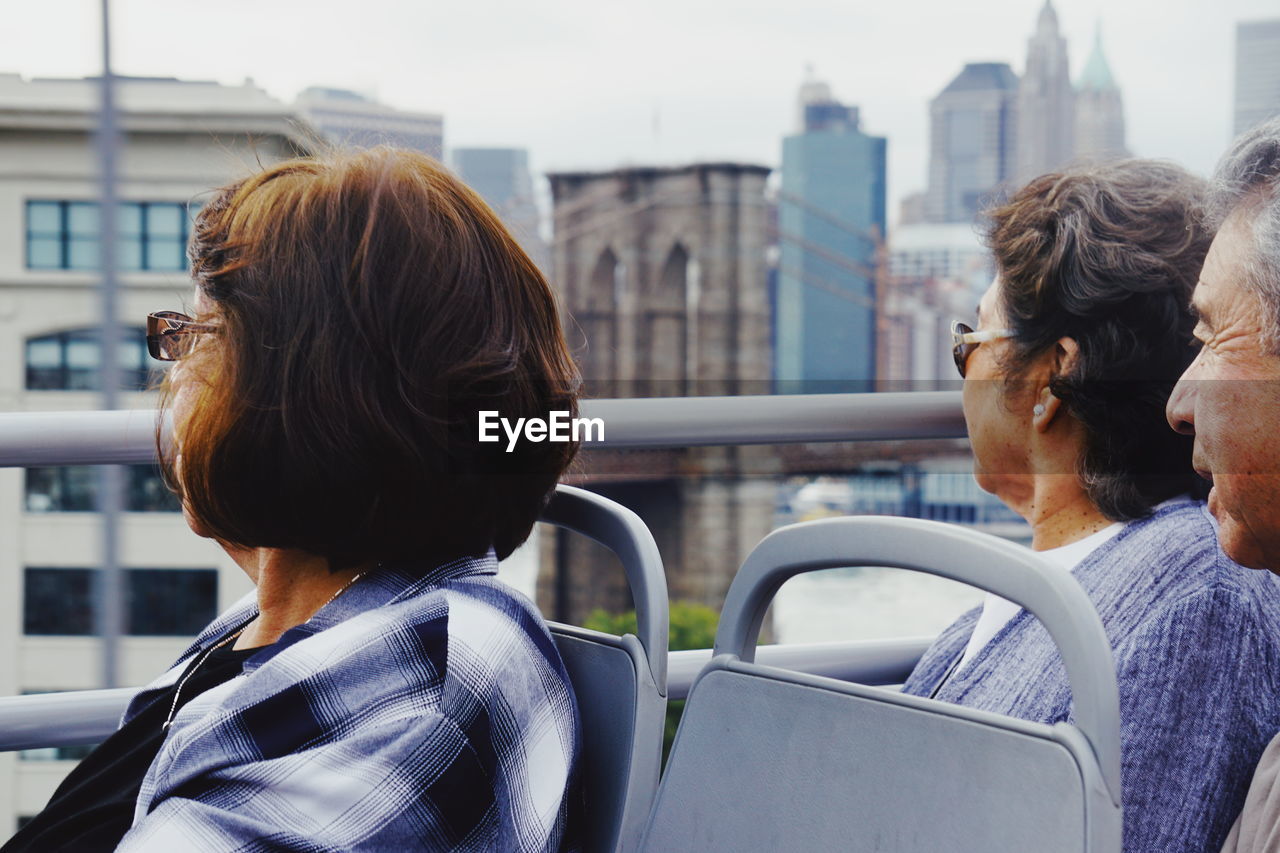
0, 392, 965, 751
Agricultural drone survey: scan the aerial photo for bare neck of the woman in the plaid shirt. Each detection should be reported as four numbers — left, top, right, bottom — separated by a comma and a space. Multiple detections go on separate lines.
227, 548, 369, 649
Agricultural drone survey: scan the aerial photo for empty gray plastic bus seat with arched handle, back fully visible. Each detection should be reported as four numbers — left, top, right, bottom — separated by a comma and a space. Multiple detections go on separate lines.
643, 516, 1121, 853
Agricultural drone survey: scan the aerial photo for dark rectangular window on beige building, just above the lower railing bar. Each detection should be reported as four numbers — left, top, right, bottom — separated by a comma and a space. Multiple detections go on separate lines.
22, 566, 218, 637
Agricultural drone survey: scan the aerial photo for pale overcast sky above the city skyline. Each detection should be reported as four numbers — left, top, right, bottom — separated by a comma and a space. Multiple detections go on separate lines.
0, 0, 1280, 219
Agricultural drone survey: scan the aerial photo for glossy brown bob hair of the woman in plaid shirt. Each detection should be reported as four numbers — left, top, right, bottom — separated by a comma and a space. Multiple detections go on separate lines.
161, 147, 579, 570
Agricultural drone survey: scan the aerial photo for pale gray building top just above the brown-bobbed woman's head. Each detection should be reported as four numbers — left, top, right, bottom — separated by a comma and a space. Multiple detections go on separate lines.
293, 86, 444, 160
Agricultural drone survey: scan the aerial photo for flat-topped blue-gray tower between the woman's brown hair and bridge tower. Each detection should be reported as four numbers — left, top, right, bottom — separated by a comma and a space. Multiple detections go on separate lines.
449, 147, 548, 269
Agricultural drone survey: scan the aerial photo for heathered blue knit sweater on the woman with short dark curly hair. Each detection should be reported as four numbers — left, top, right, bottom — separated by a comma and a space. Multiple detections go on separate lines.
904, 501, 1280, 853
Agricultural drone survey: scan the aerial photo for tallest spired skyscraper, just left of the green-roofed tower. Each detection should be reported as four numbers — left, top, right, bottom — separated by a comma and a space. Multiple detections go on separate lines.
1015, 0, 1075, 186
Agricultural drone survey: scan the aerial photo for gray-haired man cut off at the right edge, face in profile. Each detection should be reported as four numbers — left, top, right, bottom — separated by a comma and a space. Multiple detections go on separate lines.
1166, 118, 1280, 853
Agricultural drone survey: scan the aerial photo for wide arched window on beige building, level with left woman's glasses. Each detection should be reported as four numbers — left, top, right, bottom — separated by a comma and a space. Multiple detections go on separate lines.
27, 327, 160, 391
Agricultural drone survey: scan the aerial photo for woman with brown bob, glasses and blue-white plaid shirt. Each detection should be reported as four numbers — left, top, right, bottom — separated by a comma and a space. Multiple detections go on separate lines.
5, 149, 580, 850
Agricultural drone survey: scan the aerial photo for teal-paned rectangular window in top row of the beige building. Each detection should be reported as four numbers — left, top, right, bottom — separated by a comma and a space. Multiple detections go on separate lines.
27, 201, 191, 272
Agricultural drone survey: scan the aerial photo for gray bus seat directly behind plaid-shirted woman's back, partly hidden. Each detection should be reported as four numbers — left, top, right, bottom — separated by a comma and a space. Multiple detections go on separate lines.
541, 485, 668, 853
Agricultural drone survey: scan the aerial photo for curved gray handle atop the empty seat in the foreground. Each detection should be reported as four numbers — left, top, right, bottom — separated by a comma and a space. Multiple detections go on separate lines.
716, 516, 1120, 806
